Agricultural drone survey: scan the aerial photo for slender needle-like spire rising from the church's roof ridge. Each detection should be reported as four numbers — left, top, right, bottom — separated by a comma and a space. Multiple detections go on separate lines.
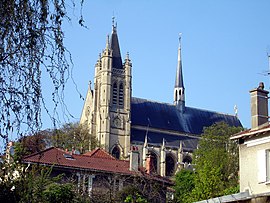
174, 33, 185, 112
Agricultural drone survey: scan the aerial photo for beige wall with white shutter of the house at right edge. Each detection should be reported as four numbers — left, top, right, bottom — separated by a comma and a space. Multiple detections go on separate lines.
239, 132, 270, 195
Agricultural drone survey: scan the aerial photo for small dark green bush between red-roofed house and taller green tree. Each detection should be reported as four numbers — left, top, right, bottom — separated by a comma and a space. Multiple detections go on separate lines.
174, 169, 195, 202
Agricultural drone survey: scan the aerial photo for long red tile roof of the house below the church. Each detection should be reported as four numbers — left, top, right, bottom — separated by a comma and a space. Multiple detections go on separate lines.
23, 147, 172, 185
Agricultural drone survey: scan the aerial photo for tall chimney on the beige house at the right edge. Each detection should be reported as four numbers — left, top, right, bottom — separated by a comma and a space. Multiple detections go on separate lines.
249, 82, 269, 129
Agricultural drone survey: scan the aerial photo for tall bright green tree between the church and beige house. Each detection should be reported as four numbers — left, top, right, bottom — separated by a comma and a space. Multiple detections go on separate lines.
191, 122, 242, 201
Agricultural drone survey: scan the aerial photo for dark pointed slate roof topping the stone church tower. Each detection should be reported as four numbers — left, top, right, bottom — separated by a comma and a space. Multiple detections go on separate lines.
110, 26, 123, 69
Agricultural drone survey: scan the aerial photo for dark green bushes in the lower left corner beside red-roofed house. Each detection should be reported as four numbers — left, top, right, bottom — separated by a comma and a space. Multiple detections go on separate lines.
0, 142, 82, 203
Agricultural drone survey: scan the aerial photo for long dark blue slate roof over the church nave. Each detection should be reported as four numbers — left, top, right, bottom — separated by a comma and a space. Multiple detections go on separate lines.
131, 97, 242, 149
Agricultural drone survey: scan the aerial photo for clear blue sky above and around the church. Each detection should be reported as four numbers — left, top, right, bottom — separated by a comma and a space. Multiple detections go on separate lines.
43, 0, 270, 128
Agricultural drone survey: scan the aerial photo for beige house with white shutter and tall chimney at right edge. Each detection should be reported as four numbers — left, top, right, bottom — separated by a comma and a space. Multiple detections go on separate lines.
197, 82, 270, 203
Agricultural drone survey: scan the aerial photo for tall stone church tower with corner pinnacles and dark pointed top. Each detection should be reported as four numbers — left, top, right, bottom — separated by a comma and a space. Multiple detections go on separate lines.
80, 24, 132, 158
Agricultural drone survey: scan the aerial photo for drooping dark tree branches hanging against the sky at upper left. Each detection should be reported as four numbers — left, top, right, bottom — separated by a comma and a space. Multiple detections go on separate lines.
0, 0, 84, 146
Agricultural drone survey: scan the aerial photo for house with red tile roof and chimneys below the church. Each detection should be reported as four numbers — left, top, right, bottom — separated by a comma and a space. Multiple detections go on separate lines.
23, 147, 173, 202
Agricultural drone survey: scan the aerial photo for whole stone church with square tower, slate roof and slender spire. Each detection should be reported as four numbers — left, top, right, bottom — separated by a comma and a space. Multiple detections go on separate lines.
80, 23, 241, 177
